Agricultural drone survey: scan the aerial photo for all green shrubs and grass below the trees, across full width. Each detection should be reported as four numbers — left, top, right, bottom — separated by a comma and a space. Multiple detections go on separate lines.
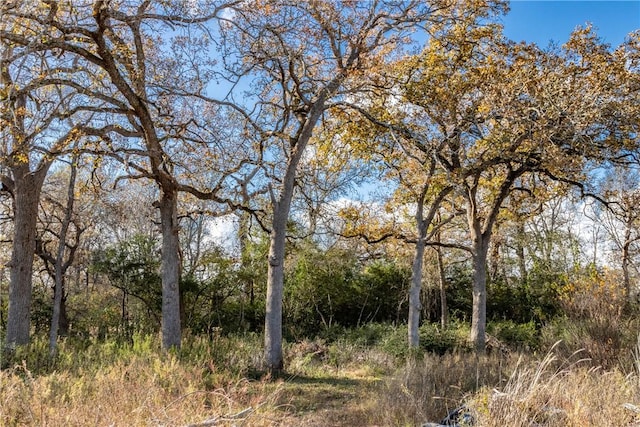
0, 231, 640, 426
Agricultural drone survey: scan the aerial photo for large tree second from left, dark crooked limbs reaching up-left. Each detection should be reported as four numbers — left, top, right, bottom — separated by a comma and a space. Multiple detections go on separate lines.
0, 0, 242, 349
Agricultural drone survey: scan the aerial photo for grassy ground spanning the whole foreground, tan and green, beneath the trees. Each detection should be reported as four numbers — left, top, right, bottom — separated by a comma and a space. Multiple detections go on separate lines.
0, 328, 640, 427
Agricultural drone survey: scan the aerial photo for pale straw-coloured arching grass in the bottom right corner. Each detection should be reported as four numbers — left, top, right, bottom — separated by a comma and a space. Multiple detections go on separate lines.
469, 342, 640, 427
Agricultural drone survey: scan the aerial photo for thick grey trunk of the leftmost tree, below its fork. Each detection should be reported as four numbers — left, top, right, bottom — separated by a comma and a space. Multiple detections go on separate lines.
6, 164, 49, 349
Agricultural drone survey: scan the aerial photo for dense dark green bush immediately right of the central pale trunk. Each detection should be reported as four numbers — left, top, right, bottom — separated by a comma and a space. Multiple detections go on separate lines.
283, 245, 409, 339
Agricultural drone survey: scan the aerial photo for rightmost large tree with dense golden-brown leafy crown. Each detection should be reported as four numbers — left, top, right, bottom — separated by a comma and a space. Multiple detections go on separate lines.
384, 26, 632, 351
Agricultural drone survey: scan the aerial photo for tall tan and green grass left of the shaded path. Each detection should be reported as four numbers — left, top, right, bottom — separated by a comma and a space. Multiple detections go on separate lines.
0, 336, 287, 426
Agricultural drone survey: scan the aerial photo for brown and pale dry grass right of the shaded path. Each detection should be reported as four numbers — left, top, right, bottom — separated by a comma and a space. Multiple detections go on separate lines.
370, 346, 640, 427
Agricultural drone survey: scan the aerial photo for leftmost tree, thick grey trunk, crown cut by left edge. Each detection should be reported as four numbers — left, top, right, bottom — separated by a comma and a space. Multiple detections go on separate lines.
0, 12, 88, 348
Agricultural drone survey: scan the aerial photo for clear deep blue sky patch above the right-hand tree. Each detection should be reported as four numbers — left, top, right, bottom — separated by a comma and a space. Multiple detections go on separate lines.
502, 0, 640, 47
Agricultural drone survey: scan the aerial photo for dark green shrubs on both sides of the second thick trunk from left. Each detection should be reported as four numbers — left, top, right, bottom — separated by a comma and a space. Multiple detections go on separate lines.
89, 235, 266, 340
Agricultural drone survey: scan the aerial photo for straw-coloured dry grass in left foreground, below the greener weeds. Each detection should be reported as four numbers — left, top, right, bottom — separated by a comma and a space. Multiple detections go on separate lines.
0, 357, 286, 426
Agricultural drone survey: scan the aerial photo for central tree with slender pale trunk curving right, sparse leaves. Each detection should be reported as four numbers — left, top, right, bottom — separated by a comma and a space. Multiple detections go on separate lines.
215, 0, 446, 370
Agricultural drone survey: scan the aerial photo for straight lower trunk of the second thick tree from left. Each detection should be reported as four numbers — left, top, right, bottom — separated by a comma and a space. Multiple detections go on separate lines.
159, 189, 181, 350
